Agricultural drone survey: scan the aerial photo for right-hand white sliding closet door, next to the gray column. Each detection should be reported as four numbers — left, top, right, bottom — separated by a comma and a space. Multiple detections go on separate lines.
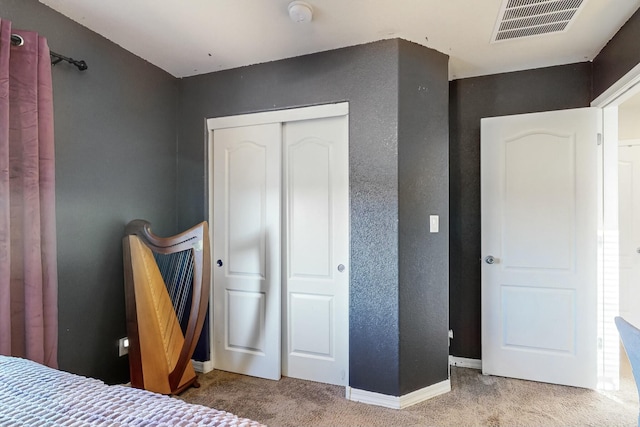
282, 116, 349, 385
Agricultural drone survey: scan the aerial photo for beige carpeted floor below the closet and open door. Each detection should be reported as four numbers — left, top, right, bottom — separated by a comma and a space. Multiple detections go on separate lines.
180, 367, 638, 427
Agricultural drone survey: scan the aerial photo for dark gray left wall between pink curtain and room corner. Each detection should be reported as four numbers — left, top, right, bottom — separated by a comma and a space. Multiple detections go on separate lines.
0, 0, 177, 382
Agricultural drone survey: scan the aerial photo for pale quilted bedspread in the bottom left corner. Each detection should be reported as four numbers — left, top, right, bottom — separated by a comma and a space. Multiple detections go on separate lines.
0, 356, 261, 427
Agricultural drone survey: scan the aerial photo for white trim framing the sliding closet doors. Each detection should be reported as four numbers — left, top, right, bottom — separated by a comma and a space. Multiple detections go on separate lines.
205, 102, 350, 378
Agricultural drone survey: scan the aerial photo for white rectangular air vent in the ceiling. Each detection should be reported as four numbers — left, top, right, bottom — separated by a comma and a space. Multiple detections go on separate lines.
491, 0, 586, 42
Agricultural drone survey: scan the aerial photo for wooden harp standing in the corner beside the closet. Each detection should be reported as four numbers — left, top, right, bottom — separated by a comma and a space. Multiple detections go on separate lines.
122, 220, 211, 394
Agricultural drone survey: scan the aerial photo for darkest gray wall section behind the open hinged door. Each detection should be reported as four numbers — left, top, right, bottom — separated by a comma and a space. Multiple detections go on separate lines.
449, 62, 591, 359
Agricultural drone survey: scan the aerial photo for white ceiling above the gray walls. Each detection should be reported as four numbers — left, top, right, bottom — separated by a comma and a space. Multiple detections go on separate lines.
40, 0, 640, 79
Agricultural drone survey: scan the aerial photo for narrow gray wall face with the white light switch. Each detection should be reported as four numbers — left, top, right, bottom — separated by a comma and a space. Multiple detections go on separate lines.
398, 43, 449, 395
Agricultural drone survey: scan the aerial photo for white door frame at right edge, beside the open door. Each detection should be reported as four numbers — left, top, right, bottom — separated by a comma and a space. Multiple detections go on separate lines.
591, 64, 640, 390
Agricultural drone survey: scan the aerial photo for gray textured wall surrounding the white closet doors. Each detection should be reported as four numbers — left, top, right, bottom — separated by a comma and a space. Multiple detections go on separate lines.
178, 40, 447, 396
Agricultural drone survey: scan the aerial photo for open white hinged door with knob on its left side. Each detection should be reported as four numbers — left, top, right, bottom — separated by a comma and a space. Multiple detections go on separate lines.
481, 108, 601, 388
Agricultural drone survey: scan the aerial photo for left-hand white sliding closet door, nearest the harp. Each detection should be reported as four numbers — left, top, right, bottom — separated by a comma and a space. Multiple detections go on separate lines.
212, 123, 282, 379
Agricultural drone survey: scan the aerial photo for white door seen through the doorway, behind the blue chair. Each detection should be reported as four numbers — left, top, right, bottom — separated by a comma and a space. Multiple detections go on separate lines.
618, 144, 640, 326
